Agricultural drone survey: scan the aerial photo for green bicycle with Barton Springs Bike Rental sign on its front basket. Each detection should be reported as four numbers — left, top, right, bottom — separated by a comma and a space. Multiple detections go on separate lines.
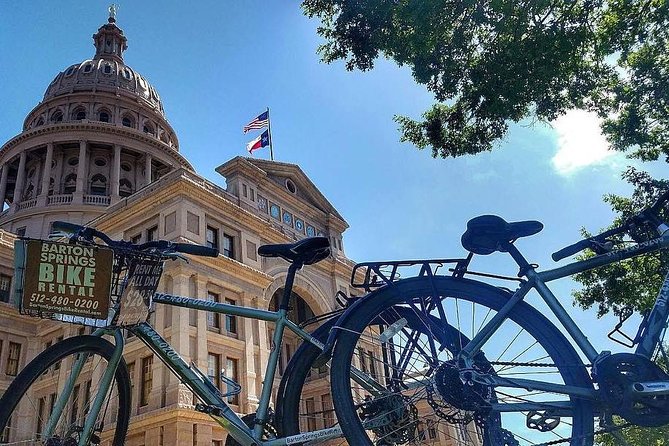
0, 222, 368, 446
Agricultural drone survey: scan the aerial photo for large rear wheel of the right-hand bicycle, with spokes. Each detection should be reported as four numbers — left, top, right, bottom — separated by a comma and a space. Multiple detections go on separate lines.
331, 277, 594, 446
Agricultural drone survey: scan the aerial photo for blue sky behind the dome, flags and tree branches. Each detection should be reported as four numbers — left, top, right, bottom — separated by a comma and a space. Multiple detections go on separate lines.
0, 0, 666, 350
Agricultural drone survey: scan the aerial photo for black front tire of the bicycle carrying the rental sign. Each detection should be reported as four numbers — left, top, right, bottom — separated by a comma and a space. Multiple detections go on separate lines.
0, 335, 132, 446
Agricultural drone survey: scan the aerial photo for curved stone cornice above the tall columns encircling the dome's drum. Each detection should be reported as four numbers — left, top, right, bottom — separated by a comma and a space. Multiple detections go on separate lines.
0, 120, 194, 171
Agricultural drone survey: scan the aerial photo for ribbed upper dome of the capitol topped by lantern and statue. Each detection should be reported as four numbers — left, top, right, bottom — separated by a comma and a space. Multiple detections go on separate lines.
42, 17, 165, 117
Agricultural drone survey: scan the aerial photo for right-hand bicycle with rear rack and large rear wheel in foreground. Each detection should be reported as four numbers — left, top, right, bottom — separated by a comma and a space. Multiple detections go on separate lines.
321, 191, 669, 446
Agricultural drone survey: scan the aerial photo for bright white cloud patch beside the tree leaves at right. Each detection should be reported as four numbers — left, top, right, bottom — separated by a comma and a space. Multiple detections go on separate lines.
551, 110, 620, 175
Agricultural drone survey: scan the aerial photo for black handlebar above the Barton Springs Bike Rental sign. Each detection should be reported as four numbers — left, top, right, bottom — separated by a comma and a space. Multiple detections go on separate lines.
52, 221, 218, 257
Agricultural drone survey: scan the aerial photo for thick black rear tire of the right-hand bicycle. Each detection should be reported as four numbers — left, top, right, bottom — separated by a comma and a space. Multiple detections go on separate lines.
331, 276, 594, 446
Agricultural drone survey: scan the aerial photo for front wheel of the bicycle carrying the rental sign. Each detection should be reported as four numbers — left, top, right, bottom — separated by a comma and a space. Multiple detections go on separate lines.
0, 336, 131, 446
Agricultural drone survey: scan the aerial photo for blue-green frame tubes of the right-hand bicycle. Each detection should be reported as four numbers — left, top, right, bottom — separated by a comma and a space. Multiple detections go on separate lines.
460, 232, 669, 404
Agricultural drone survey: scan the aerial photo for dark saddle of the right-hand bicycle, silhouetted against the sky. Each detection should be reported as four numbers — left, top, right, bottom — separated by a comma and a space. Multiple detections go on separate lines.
461, 215, 544, 255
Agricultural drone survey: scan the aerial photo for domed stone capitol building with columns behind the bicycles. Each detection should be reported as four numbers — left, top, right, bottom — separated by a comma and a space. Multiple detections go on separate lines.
0, 12, 462, 446
